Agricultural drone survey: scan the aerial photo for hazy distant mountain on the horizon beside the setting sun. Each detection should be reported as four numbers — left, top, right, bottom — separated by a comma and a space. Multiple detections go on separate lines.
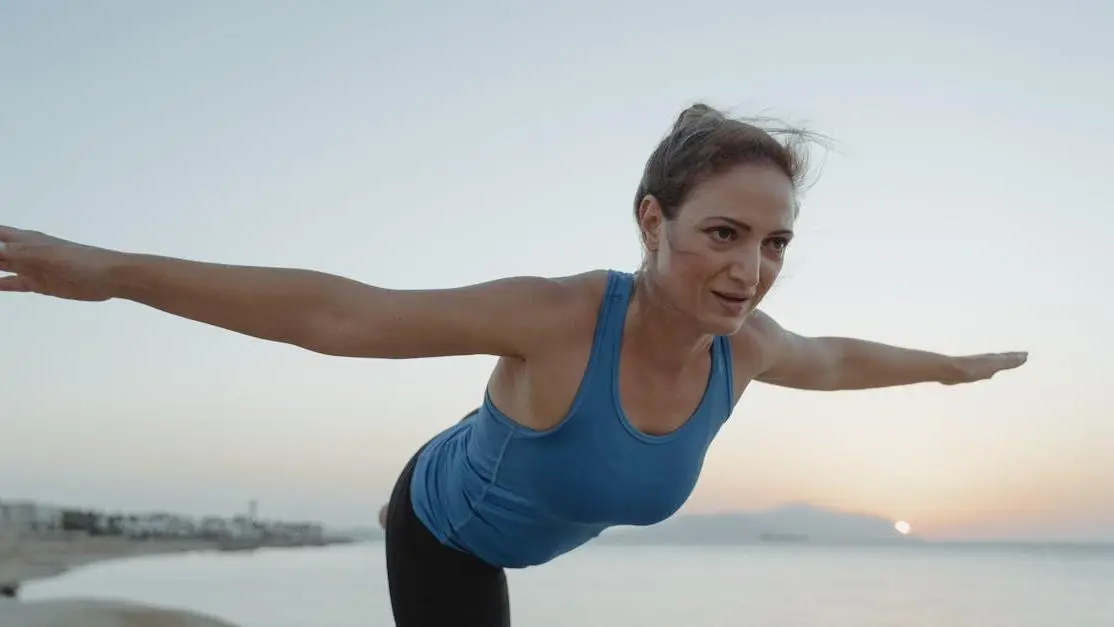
599, 503, 910, 545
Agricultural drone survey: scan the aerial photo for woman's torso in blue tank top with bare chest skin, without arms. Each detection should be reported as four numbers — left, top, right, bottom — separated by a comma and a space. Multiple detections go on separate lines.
412, 272, 745, 567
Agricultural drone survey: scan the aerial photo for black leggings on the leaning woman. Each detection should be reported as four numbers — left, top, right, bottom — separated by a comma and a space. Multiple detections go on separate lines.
387, 436, 510, 627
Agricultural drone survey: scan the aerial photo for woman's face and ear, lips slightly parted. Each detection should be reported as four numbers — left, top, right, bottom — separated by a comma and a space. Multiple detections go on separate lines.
638, 165, 797, 335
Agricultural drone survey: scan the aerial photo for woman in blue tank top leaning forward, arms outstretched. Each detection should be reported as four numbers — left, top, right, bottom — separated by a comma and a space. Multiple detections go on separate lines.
0, 105, 1026, 627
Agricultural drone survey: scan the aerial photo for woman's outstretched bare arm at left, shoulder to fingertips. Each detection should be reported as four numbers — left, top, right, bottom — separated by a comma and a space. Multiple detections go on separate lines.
0, 227, 584, 359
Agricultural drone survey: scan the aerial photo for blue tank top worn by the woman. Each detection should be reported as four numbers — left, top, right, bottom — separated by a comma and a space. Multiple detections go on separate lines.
411, 272, 734, 568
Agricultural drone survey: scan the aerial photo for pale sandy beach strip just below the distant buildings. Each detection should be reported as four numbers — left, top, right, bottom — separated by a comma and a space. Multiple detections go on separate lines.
0, 533, 217, 586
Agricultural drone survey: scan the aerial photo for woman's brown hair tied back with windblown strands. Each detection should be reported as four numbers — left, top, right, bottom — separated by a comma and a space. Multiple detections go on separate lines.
634, 102, 820, 219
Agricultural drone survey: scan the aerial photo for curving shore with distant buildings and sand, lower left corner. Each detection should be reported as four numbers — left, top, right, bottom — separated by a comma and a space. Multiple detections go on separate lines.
0, 500, 350, 627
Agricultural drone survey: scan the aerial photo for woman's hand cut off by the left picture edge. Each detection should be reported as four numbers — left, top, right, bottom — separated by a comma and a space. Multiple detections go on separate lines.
0, 226, 120, 301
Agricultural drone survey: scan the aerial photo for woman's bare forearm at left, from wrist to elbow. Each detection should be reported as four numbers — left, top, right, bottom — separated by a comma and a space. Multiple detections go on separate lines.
110, 253, 368, 352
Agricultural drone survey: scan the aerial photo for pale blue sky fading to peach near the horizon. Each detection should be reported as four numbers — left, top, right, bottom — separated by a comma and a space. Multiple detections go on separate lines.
0, 0, 1114, 540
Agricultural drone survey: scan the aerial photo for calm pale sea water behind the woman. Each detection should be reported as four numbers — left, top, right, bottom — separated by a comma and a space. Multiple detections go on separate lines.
23, 545, 1114, 627
